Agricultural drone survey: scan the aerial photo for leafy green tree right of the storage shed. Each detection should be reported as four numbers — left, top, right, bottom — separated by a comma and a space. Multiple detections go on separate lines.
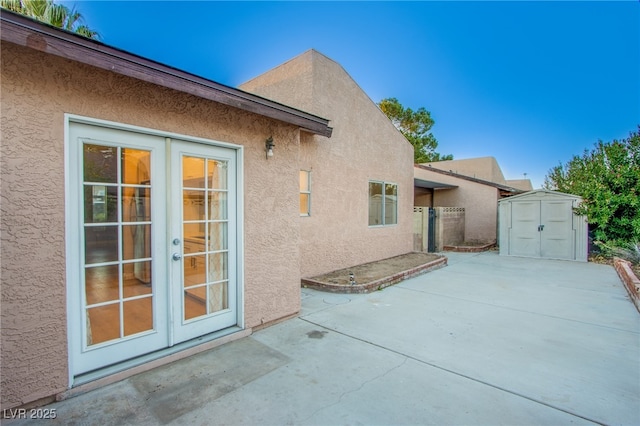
544, 126, 640, 245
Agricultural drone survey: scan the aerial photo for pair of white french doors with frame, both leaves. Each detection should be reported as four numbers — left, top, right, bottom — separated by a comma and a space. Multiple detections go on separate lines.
67, 122, 239, 376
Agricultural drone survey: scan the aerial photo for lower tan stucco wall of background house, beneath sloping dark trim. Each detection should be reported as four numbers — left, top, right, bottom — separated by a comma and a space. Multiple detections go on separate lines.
415, 167, 499, 242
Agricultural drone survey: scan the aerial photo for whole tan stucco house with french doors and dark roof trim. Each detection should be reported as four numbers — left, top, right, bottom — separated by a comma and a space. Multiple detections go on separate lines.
0, 10, 413, 409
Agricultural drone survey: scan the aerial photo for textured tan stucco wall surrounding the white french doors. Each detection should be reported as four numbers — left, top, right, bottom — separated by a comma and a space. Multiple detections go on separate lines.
0, 43, 300, 408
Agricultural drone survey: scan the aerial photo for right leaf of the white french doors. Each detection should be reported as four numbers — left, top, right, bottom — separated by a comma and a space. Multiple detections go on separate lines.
171, 141, 237, 342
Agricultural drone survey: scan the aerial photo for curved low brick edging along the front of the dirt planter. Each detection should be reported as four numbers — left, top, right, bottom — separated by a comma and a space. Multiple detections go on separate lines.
301, 256, 447, 294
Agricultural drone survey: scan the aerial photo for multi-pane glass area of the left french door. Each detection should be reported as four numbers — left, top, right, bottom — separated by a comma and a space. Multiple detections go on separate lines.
83, 144, 154, 346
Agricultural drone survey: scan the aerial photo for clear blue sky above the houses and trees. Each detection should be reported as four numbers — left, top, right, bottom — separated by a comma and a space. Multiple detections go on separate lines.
63, 1, 640, 188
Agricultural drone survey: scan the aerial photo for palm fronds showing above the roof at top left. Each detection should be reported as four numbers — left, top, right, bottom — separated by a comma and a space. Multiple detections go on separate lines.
0, 0, 100, 39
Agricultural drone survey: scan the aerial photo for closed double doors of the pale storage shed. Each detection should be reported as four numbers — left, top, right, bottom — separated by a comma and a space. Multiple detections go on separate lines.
509, 200, 575, 259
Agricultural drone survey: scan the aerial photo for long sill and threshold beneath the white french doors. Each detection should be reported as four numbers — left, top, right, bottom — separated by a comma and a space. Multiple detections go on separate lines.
63, 326, 252, 401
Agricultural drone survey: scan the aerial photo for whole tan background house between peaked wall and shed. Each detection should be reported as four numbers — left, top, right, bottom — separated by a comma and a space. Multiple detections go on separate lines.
414, 157, 531, 243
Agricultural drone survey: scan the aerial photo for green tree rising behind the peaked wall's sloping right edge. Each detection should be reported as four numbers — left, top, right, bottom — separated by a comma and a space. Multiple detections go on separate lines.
378, 98, 453, 163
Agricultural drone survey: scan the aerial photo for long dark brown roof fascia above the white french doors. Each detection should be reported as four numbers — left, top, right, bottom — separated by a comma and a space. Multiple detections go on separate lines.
0, 9, 333, 137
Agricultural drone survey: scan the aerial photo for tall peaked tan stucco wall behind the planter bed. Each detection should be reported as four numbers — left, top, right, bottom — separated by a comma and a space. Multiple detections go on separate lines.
240, 50, 413, 277
